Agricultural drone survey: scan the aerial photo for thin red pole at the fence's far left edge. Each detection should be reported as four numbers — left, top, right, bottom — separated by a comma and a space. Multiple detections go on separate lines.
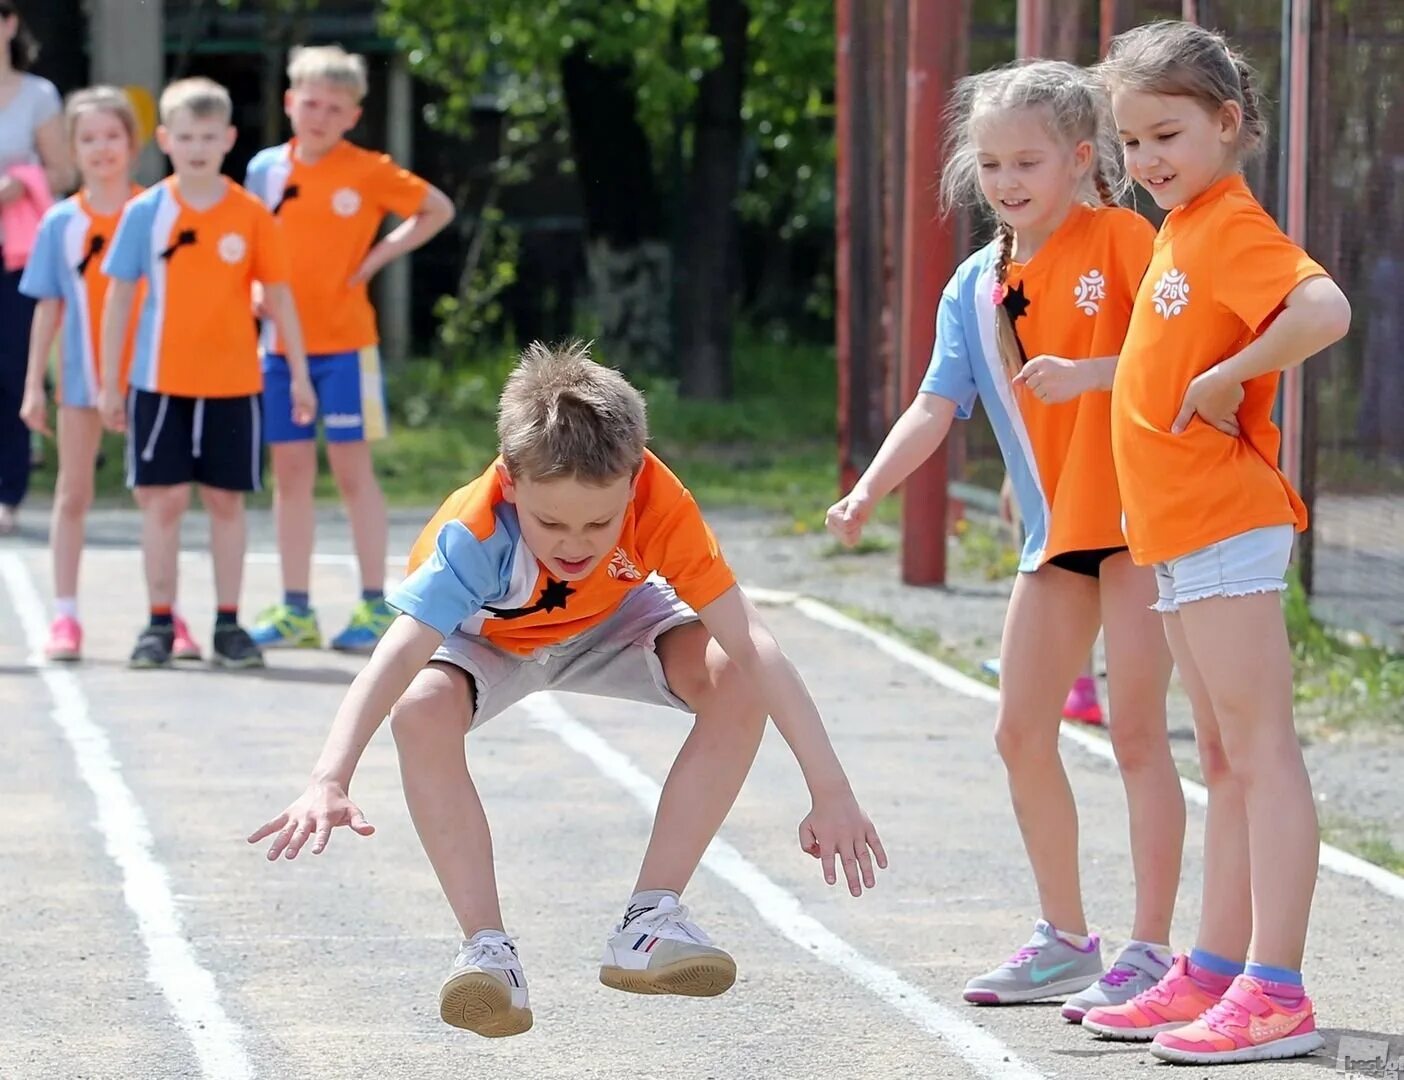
834, 0, 858, 492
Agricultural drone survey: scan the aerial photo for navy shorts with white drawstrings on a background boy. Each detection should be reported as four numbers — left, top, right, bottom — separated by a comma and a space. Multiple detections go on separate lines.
126, 389, 263, 492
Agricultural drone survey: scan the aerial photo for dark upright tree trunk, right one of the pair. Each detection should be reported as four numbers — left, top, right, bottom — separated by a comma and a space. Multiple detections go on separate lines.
678, 0, 751, 399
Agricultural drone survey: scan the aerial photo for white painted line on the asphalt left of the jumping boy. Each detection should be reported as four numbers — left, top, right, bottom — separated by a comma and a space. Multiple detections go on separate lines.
0, 552, 254, 1080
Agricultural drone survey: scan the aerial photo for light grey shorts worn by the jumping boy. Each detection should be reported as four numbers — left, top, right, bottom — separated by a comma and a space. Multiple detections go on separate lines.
431, 580, 696, 729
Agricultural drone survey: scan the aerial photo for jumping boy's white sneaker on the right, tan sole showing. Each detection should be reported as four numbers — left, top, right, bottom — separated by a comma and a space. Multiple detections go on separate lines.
600, 896, 736, 997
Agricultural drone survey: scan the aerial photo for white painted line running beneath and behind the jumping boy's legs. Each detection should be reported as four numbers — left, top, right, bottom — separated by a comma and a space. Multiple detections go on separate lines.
519, 694, 1043, 1080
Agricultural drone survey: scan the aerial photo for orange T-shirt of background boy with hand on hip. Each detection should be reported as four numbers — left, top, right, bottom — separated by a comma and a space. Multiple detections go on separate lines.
246, 139, 430, 354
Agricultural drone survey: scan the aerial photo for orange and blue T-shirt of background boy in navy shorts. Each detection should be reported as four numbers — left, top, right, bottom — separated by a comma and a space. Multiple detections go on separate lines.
102, 177, 289, 397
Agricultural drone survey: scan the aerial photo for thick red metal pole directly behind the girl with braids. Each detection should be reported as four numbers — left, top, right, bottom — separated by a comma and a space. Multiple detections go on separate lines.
901, 0, 967, 586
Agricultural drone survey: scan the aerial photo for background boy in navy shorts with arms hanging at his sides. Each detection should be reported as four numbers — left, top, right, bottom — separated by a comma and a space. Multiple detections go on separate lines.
100, 79, 317, 667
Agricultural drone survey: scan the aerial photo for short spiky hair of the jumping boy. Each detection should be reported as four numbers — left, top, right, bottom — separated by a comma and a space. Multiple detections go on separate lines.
497, 341, 649, 485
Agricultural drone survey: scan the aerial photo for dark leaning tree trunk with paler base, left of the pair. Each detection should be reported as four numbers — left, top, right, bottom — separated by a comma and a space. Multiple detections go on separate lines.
560, 48, 673, 372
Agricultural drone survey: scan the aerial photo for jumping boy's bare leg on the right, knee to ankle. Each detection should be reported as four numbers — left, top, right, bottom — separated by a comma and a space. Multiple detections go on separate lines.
635, 622, 765, 893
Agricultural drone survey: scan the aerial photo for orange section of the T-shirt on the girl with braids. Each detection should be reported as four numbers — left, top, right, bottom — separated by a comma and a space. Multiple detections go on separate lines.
1005, 204, 1155, 560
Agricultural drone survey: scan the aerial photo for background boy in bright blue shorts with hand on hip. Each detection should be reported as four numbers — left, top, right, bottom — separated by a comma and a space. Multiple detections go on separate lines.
246, 46, 453, 652
